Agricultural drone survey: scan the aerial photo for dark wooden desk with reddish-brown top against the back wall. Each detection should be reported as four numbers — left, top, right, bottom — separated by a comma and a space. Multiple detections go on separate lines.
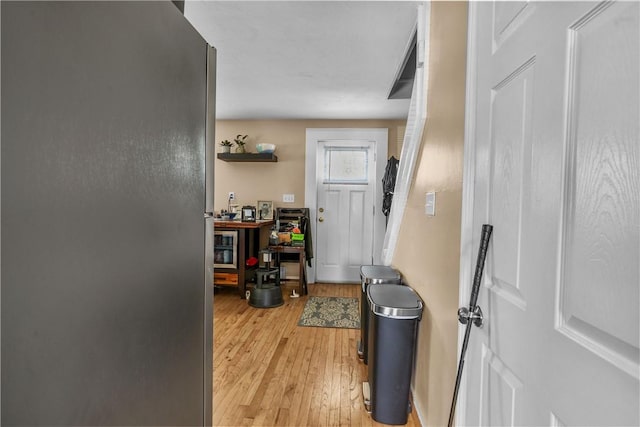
213, 220, 275, 298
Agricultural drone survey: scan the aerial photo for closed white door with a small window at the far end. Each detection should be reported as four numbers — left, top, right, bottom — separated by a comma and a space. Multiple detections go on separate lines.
316, 140, 376, 282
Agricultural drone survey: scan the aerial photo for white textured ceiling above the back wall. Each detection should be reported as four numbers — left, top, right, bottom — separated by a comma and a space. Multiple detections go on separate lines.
184, 0, 418, 120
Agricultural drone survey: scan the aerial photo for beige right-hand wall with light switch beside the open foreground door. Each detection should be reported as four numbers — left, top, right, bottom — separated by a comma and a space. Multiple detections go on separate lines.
392, 2, 467, 426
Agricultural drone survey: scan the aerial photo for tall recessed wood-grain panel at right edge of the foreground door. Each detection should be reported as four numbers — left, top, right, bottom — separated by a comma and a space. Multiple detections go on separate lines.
556, 0, 640, 375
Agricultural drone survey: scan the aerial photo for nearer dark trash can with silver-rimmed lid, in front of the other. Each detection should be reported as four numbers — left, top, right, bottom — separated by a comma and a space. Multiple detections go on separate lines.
367, 285, 422, 424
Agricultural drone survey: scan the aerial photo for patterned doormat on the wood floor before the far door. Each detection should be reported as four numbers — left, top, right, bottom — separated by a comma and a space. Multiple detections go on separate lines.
298, 297, 360, 329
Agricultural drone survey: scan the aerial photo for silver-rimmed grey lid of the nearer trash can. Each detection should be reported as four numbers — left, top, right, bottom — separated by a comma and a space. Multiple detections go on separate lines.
367, 284, 422, 319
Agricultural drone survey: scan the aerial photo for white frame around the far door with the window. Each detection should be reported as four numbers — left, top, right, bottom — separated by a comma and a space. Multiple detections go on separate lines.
304, 128, 389, 283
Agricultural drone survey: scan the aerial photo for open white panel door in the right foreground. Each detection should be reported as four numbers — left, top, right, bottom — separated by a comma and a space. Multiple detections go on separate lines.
458, 2, 640, 426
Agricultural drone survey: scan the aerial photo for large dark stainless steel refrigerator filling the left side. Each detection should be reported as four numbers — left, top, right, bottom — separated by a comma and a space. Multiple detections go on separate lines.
0, 1, 215, 426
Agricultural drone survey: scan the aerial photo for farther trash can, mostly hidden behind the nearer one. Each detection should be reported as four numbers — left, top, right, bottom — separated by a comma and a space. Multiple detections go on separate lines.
358, 265, 401, 364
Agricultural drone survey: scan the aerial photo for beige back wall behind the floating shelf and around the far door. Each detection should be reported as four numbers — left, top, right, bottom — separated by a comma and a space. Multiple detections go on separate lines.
214, 120, 405, 211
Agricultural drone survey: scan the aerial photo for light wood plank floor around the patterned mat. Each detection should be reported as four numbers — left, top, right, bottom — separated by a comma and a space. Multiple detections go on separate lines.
213, 284, 420, 426
